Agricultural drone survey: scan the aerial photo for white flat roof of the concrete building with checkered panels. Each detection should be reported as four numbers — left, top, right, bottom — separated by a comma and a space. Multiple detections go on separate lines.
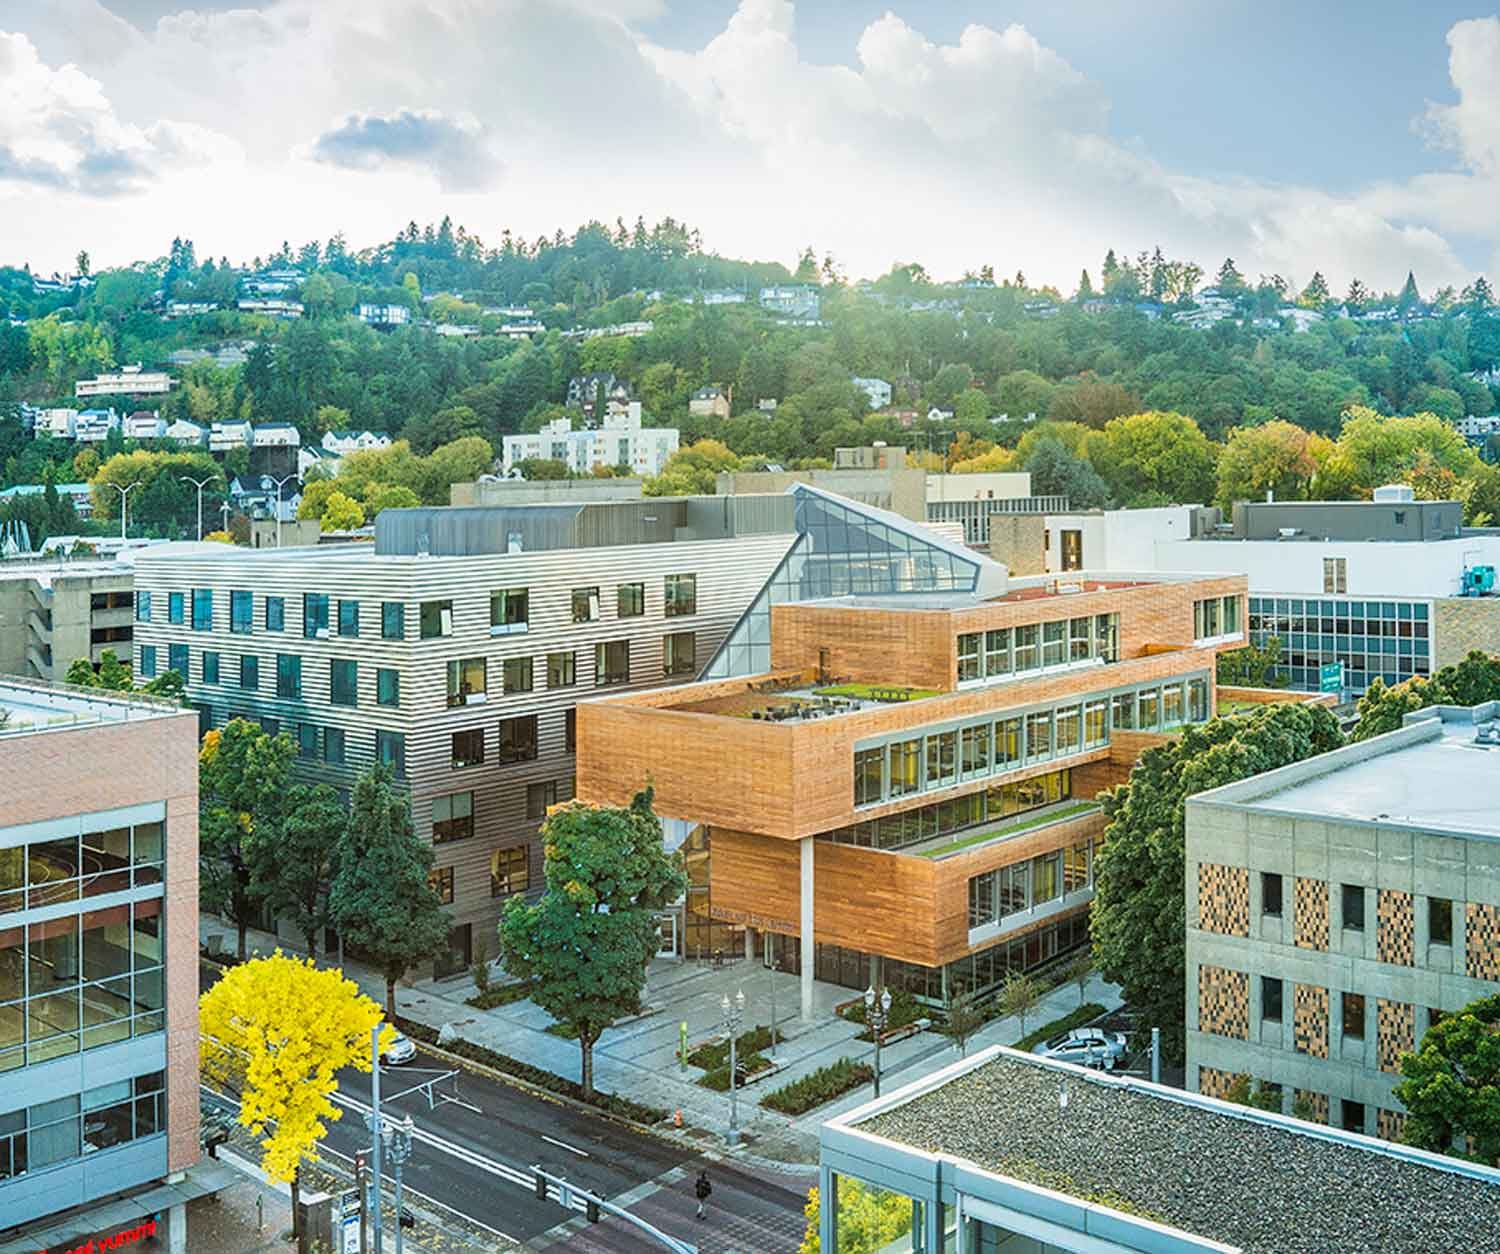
1194, 702, 1500, 839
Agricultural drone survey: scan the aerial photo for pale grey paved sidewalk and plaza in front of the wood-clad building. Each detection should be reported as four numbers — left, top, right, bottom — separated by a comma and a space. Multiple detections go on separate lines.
200, 915, 1121, 1167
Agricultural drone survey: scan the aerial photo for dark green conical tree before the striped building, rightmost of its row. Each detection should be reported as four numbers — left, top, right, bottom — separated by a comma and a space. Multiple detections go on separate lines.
330, 764, 452, 1017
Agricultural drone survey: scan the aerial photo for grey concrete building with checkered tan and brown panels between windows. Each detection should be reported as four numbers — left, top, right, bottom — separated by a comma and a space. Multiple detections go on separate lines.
1187, 704, 1500, 1139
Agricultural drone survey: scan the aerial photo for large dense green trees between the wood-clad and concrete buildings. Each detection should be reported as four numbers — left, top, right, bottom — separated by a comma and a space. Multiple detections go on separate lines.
1091, 705, 1343, 1061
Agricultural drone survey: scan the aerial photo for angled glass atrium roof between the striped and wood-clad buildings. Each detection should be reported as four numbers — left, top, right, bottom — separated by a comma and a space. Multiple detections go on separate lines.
699, 483, 1005, 680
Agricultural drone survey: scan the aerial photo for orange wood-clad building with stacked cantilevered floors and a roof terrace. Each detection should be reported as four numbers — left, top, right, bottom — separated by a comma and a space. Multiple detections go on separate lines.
578, 564, 1245, 1013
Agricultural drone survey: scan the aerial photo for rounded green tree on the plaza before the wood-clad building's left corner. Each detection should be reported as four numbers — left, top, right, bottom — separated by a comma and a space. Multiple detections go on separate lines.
500, 789, 686, 1097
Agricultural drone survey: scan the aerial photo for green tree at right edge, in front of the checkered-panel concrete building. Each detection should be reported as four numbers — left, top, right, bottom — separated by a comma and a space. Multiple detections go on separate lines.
1395, 995, 1500, 1167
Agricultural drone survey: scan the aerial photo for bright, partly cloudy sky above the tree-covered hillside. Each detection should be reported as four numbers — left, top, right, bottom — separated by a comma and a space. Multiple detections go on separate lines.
0, 0, 1500, 291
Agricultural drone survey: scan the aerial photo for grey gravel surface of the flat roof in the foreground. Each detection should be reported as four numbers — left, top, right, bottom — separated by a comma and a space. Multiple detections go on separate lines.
860, 1056, 1500, 1254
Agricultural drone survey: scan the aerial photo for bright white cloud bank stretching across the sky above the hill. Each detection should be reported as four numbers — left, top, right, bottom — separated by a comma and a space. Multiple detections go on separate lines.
0, 0, 1500, 288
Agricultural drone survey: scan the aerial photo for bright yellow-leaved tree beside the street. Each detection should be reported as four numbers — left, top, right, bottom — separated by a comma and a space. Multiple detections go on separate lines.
198, 950, 395, 1217
